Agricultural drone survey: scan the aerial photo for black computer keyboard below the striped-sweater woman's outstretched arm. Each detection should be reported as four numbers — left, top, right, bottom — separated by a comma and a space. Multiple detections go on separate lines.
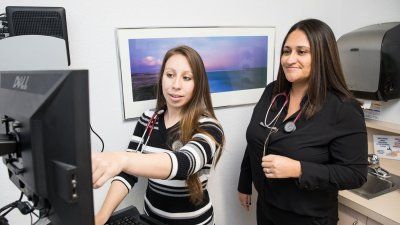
105, 206, 164, 225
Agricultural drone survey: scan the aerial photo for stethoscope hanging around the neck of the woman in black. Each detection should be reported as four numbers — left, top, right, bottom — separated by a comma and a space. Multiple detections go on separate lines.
260, 92, 301, 156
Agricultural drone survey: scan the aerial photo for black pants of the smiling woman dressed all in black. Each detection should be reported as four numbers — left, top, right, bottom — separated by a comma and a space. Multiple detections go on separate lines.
257, 199, 337, 225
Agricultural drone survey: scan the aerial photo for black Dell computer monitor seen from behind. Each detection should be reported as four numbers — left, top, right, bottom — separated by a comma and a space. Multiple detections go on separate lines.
0, 70, 94, 225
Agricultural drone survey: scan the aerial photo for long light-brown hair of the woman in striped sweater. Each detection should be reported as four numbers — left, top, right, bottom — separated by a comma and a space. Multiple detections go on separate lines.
156, 45, 224, 204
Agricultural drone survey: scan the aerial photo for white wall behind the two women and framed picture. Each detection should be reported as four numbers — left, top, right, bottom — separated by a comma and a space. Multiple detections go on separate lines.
0, 0, 400, 225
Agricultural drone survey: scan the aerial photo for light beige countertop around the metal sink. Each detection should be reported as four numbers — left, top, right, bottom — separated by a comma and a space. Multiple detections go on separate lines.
339, 159, 400, 225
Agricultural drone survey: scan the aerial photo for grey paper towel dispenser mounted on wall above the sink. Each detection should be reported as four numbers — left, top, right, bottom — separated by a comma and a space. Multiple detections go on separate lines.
337, 22, 400, 101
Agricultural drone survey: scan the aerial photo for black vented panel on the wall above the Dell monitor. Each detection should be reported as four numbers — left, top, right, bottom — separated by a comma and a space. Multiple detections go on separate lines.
6, 6, 71, 65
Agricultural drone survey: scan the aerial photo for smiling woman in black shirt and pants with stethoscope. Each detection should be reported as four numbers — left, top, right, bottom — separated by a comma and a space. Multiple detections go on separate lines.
238, 19, 368, 225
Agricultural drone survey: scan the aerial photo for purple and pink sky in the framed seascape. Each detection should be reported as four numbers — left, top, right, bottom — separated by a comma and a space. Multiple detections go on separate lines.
129, 36, 268, 75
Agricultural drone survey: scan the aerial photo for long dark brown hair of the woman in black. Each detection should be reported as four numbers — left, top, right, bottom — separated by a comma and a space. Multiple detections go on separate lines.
273, 19, 353, 118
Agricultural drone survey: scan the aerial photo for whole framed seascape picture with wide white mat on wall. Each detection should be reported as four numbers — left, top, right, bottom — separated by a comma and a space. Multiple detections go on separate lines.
117, 27, 275, 119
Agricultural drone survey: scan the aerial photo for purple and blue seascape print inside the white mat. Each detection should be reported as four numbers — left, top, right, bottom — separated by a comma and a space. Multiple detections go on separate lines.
129, 36, 268, 101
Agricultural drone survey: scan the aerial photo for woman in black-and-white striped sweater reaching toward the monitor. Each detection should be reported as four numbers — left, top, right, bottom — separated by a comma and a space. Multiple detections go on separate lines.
92, 46, 224, 225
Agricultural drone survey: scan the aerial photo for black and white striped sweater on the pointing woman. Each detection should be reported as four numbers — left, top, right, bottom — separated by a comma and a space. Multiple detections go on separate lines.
114, 110, 223, 225
